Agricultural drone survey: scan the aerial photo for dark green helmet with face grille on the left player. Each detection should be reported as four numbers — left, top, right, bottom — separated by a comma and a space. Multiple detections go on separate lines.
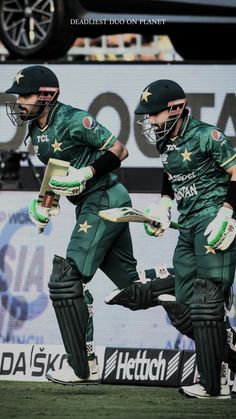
5, 65, 59, 126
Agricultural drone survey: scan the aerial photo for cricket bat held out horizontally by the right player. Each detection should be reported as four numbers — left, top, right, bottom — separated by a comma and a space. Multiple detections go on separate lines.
98, 207, 178, 230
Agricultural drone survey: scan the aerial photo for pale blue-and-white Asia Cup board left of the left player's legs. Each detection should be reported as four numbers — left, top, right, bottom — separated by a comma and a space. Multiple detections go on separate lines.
0, 191, 72, 344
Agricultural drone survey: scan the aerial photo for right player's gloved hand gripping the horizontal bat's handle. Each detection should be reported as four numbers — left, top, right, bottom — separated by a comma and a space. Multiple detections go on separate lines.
144, 197, 172, 237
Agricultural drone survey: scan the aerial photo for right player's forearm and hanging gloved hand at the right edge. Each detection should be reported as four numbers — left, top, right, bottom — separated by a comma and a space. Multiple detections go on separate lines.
204, 164, 236, 250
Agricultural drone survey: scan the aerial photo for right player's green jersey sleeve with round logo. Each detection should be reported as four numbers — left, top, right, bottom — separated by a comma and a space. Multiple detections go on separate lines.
200, 127, 236, 170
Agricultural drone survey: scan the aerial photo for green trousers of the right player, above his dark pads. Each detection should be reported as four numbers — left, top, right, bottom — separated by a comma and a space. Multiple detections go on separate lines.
173, 217, 236, 304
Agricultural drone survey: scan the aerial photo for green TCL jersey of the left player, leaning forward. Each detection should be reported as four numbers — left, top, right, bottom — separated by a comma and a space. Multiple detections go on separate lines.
29, 102, 117, 204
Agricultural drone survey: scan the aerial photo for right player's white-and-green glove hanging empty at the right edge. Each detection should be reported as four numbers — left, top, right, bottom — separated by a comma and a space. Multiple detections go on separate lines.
204, 207, 236, 250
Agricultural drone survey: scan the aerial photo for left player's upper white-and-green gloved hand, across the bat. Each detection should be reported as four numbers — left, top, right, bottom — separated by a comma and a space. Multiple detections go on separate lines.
49, 166, 93, 196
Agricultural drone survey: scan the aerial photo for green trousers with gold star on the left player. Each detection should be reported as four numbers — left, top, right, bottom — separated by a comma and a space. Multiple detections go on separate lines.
67, 183, 138, 288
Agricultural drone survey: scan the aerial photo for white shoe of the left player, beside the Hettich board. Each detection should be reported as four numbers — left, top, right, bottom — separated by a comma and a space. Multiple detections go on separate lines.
45, 360, 101, 386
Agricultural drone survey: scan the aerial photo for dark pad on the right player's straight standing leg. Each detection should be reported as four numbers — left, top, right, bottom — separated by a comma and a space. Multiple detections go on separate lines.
190, 278, 227, 396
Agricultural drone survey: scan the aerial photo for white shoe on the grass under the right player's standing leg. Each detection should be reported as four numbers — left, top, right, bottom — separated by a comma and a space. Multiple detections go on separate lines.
179, 383, 231, 400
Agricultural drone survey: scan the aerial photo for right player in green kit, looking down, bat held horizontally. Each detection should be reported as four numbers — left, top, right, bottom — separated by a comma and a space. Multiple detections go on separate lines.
107, 80, 236, 399
